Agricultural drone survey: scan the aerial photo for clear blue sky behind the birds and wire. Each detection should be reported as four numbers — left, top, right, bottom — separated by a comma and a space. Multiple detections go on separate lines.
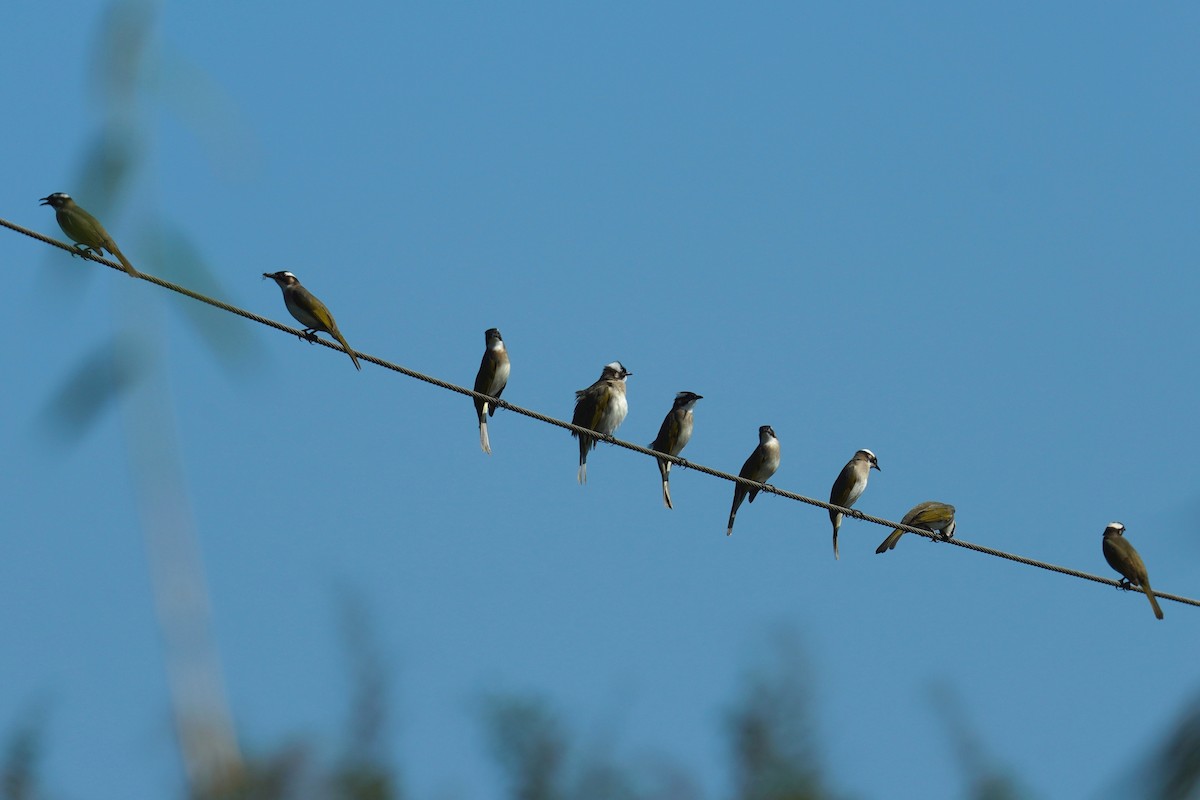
0, 2, 1200, 799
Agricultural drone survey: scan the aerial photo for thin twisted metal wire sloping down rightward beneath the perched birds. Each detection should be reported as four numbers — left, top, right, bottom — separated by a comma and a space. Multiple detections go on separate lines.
7, 218, 1200, 607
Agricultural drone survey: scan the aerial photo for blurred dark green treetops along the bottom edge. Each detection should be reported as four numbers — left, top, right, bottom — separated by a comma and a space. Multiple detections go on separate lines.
14, 623, 1200, 800
